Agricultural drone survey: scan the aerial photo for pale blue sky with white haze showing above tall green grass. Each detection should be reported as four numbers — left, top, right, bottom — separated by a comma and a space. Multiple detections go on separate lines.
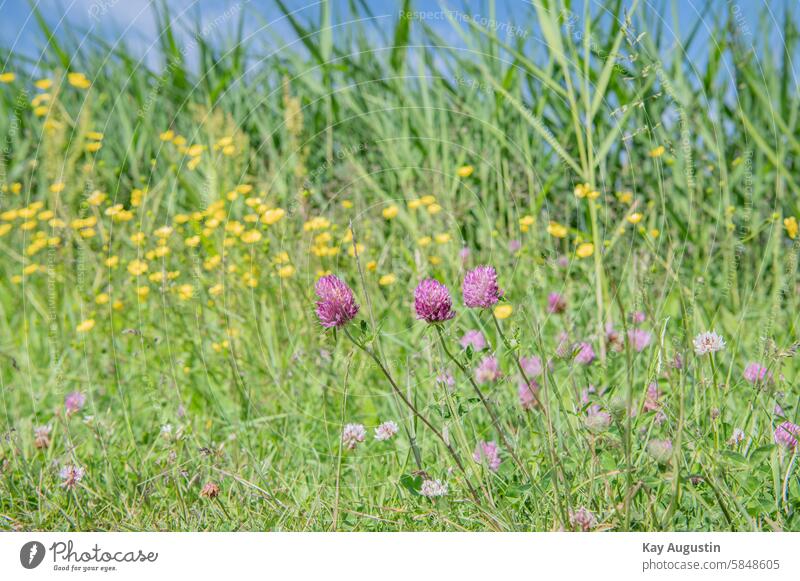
0, 0, 800, 71
